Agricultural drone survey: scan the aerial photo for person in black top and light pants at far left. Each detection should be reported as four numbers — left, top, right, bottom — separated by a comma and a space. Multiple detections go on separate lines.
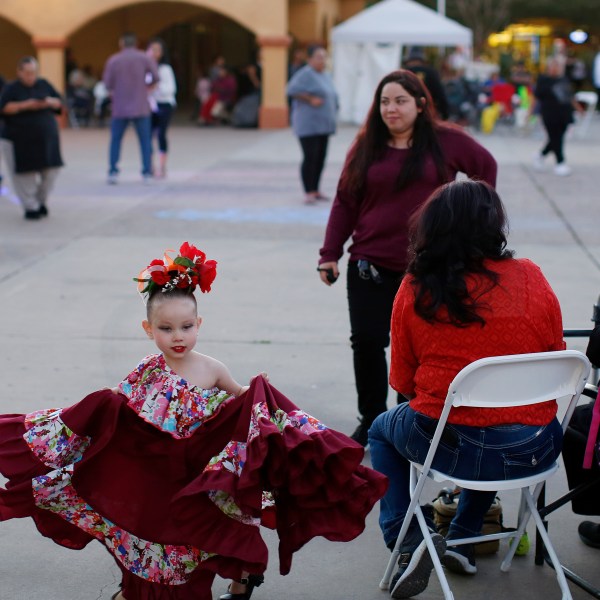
0, 56, 63, 220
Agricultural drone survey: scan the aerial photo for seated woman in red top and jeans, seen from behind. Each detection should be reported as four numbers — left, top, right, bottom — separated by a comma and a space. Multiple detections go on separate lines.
369, 181, 565, 598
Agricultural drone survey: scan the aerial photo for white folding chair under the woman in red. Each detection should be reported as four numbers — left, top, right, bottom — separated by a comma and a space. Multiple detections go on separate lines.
379, 350, 591, 600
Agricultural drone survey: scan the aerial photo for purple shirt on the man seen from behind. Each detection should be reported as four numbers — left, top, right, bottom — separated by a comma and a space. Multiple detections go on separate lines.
102, 48, 159, 118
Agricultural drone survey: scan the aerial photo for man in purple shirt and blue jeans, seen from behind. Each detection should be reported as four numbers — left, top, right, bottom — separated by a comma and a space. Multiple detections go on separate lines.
102, 33, 158, 184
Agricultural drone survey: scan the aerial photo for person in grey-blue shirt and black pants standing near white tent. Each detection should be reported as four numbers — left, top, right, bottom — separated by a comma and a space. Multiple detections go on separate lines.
287, 46, 338, 204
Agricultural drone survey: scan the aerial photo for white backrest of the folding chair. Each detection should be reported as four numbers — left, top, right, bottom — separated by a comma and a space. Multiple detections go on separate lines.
446, 350, 591, 408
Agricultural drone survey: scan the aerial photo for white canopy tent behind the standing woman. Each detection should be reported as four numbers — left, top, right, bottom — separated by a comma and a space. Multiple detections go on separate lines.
332, 0, 473, 124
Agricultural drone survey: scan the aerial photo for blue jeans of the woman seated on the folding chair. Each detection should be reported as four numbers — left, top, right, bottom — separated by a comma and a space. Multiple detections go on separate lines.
369, 402, 562, 551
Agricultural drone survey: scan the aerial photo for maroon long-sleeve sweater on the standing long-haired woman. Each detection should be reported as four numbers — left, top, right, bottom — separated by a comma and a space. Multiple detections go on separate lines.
319, 127, 497, 272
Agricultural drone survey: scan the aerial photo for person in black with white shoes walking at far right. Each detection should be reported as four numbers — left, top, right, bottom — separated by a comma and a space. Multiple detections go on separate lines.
533, 57, 574, 177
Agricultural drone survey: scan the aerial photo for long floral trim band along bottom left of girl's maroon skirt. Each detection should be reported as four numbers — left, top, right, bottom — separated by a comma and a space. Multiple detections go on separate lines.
32, 465, 214, 585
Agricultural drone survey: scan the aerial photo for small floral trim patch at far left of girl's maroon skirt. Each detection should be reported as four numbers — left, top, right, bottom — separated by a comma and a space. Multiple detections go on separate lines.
23, 408, 90, 469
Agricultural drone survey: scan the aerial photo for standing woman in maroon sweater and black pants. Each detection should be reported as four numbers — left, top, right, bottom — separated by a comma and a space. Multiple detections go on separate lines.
319, 70, 496, 446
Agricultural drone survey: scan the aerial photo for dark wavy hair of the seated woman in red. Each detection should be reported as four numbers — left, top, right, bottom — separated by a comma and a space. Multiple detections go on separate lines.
407, 180, 513, 327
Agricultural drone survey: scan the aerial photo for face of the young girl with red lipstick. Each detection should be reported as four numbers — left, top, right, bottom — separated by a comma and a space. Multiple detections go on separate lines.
142, 297, 202, 362
